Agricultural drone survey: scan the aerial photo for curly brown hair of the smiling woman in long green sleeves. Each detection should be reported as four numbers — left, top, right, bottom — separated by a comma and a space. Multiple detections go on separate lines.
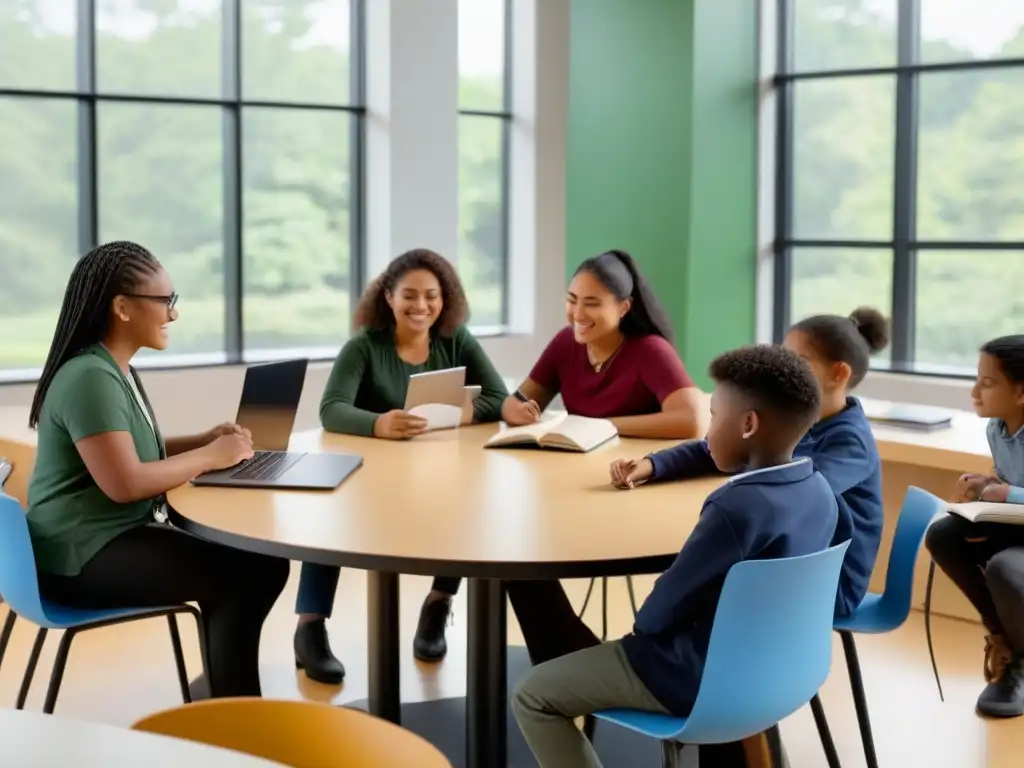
353, 248, 469, 336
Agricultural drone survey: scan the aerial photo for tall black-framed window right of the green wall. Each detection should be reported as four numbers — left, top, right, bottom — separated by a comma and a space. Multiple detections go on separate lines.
775, 0, 1024, 373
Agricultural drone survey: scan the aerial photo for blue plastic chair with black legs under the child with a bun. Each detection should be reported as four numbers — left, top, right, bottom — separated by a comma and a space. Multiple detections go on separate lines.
811, 485, 946, 768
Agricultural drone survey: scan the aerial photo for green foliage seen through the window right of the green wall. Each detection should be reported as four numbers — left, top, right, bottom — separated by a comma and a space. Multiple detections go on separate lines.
792, 0, 1024, 369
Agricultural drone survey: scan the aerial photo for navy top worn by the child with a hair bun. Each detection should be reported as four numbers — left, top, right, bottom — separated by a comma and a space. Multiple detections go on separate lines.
647, 397, 884, 616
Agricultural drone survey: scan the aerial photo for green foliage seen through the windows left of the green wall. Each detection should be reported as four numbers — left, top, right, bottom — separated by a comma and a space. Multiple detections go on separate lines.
0, 0, 504, 369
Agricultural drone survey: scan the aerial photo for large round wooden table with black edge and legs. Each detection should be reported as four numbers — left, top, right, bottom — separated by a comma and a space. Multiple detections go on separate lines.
168, 425, 722, 768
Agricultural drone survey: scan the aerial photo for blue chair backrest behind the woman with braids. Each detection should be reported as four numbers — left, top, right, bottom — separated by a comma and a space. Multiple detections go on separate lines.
0, 492, 49, 626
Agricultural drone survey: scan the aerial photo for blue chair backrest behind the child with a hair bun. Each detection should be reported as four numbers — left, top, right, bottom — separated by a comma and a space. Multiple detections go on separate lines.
882, 485, 946, 624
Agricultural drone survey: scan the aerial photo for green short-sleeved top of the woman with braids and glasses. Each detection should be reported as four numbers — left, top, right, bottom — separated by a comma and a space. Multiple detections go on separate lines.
28, 345, 162, 575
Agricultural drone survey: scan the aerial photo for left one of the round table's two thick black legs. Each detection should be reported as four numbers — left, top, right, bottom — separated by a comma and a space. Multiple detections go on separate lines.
367, 570, 401, 723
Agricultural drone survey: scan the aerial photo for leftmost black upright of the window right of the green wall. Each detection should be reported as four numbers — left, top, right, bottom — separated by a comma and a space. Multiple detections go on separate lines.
772, 0, 794, 342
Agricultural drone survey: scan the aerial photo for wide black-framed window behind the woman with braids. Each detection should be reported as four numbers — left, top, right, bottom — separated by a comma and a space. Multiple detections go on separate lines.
0, 0, 362, 373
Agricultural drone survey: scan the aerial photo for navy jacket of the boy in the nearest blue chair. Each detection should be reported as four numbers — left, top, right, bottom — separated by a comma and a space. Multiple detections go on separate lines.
622, 459, 839, 717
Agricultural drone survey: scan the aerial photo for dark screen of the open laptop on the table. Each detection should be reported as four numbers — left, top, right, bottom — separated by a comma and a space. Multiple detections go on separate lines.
236, 359, 308, 451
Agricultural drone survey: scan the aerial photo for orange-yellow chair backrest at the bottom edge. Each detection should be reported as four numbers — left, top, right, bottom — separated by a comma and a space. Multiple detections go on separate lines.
132, 698, 452, 768
